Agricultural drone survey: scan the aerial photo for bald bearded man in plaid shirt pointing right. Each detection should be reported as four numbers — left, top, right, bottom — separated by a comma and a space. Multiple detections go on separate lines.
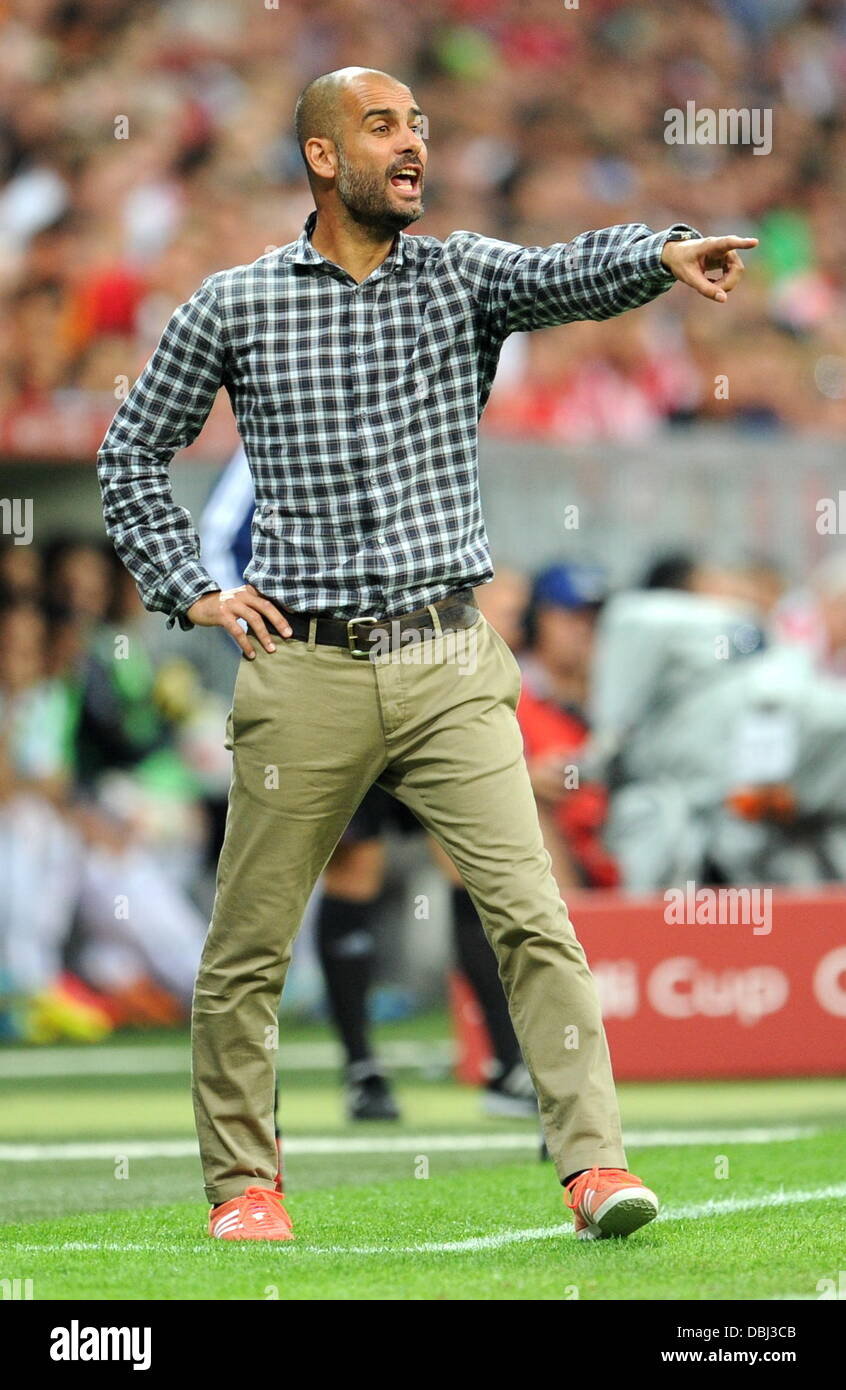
99, 68, 754, 1240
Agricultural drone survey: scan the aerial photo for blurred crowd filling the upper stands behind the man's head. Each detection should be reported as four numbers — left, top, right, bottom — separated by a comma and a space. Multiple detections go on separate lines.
0, 0, 846, 453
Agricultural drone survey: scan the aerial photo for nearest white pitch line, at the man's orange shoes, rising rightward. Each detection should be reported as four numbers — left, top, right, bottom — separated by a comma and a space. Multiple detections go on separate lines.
6, 1183, 846, 1255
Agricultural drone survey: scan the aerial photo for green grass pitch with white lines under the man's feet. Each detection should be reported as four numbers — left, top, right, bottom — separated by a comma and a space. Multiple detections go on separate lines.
0, 1020, 846, 1301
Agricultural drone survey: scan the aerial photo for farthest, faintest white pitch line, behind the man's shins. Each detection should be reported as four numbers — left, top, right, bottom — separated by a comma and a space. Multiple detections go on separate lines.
0, 1038, 456, 1081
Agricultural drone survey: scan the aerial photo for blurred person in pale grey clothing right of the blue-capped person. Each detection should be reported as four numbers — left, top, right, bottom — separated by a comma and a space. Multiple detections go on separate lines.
586, 563, 764, 892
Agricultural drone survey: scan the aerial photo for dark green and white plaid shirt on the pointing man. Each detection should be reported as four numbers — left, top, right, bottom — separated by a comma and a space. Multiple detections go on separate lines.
97, 213, 688, 627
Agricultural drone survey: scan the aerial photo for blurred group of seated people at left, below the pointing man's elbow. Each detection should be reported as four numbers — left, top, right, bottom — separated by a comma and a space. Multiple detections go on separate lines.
0, 537, 229, 1043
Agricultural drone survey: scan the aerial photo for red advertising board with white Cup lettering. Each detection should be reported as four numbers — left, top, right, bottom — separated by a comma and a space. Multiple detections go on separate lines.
453, 884, 846, 1080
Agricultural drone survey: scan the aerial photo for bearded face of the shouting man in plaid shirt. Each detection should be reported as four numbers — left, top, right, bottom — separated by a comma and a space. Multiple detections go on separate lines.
335, 78, 428, 231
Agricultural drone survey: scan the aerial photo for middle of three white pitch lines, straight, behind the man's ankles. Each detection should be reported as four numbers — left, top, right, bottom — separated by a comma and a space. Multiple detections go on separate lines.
0, 1125, 820, 1163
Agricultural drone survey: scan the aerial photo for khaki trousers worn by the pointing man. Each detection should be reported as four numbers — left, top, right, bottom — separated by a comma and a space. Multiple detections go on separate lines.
192, 614, 625, 1204
